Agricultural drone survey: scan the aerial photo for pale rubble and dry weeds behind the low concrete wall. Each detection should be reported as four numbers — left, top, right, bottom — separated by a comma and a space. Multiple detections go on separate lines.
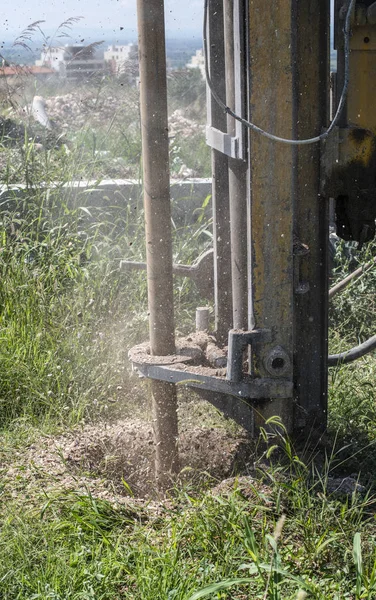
0, 88, 205, 183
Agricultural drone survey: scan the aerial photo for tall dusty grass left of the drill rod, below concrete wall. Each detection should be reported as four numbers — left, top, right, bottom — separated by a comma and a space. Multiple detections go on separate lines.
0, 172, 211, 426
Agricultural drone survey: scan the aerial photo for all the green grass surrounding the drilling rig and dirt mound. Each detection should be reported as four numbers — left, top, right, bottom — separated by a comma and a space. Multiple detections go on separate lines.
0, 182, 376, 600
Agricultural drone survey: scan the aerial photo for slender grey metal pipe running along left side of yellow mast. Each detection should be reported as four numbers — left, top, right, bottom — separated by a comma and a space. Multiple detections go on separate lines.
223, 0, 248, 329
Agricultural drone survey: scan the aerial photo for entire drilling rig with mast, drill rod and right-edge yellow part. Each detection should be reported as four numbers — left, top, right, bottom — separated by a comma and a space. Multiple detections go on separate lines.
130, 0, 376, 478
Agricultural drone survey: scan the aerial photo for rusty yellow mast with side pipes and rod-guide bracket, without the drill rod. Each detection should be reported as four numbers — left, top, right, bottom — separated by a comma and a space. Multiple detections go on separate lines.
130, 0, 329, 431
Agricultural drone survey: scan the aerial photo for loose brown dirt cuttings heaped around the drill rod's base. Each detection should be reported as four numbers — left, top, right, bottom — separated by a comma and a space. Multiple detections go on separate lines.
3, 419, 253, 503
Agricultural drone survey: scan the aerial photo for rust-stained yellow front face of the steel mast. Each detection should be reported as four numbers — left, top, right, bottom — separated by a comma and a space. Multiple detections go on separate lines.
249, 0, 293, 428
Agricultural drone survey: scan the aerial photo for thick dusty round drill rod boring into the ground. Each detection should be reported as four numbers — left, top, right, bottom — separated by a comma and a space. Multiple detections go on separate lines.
137, 0, 178, 487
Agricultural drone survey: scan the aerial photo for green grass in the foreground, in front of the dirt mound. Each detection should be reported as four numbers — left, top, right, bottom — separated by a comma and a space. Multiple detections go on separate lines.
0, 432, 376, 600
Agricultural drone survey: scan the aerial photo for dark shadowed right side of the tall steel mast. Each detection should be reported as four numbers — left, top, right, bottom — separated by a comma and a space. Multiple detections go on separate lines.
293, 0, 330, 431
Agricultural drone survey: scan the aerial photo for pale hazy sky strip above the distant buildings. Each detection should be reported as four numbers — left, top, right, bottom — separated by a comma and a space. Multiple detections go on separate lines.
0, 0, 204, 38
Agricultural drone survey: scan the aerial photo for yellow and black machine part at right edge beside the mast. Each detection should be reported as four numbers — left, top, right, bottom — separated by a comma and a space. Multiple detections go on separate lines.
325, 9, 376, 244
